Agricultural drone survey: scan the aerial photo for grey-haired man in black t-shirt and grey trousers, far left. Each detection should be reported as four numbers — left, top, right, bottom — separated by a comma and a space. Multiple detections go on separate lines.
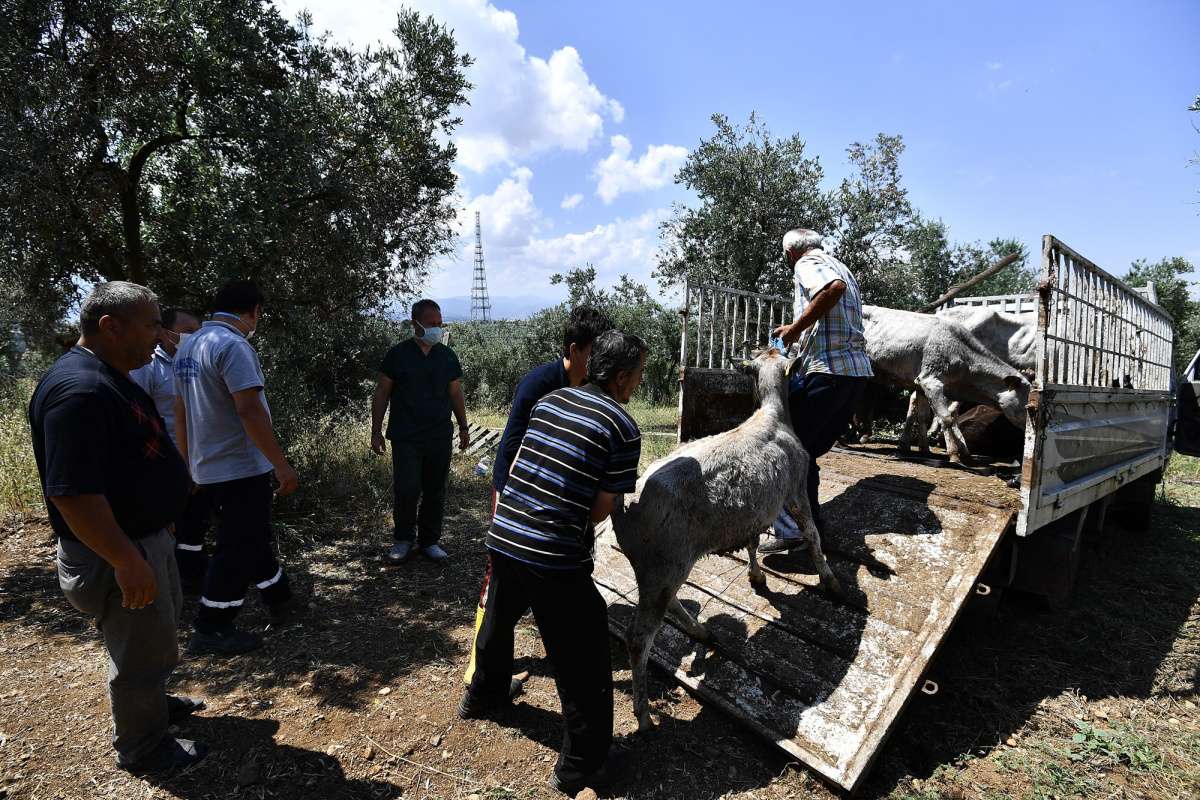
29, 281, 206, 774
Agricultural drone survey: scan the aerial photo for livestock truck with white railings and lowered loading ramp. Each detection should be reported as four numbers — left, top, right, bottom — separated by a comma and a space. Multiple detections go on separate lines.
594, 235, 1174, 792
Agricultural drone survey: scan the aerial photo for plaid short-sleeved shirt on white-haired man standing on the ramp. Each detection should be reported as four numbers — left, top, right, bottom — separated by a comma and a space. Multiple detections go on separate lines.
794, 249, 875, 378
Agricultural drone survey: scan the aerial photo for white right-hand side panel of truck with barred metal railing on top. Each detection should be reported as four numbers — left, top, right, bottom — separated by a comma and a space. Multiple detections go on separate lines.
1016, 235, 1174, 536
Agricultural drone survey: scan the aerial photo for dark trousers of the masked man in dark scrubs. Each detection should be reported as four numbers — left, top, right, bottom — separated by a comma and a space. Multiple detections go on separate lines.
391, 435, 450, 547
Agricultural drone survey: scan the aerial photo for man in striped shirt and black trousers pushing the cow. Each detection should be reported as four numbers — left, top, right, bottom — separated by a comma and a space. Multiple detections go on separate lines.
458, 331, 647, 795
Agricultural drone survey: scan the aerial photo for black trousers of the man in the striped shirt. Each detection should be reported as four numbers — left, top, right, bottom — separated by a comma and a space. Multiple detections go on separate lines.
466, 552, 612, 782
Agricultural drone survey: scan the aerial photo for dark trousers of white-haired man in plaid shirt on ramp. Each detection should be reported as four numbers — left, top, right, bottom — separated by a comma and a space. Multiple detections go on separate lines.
788, 372, 869, 531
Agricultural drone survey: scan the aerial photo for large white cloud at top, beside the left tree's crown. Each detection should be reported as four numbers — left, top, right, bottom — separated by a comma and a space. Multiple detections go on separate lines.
280, 0, 625, 173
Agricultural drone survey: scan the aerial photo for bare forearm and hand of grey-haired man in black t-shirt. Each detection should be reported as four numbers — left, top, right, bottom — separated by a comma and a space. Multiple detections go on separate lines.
50, 494, 158, 608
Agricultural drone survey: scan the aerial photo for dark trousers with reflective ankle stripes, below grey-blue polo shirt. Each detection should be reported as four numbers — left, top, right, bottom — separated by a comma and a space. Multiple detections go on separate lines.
196, 473, 292, 632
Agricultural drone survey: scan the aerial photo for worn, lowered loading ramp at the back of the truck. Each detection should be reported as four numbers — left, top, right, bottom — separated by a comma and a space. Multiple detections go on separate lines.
594, 452, 1020, 792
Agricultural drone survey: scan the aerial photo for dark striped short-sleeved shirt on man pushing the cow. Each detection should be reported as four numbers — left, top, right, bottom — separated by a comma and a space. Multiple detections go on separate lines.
487, 386, 642, 571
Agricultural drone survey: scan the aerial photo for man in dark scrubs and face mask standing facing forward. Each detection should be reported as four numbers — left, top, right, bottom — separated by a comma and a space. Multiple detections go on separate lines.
371, 300, 470, 564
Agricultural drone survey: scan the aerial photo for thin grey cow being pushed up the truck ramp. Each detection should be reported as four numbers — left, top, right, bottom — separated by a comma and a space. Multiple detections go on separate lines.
610, 348, 841, 729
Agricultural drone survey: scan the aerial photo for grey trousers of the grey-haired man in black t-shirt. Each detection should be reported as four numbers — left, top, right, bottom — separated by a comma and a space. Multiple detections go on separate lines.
58, 530, 184, 764
